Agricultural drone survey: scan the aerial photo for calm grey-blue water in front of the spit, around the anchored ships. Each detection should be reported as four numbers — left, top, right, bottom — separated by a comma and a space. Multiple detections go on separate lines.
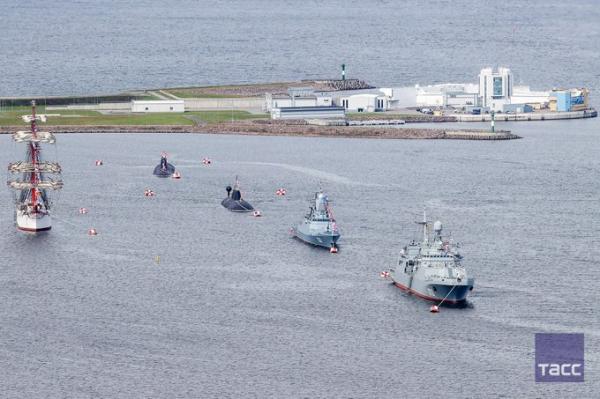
0, 120, 600, 398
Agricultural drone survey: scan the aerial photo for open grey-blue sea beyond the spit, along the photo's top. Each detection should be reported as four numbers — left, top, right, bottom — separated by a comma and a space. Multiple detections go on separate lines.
0, 0, 600, 96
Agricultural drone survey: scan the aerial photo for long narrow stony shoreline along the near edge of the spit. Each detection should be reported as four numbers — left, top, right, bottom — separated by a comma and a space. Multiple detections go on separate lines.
0, 122, 521, 140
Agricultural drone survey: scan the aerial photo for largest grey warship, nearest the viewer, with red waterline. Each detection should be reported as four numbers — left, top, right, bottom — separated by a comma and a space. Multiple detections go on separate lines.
389, 214, 475, 305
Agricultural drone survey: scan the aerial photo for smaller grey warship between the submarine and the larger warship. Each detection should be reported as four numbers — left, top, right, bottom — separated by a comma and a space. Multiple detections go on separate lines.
292, 192, 340, 252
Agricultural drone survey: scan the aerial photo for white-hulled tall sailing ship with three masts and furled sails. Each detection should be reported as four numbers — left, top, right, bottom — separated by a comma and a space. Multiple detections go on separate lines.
7, 101, 63, 232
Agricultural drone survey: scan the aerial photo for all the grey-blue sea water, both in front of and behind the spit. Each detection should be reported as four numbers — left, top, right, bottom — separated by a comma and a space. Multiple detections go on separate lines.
0, 0, 600, 398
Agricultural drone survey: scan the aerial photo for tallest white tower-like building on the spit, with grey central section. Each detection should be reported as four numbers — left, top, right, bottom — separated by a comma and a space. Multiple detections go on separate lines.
479, 67, 513, 111
